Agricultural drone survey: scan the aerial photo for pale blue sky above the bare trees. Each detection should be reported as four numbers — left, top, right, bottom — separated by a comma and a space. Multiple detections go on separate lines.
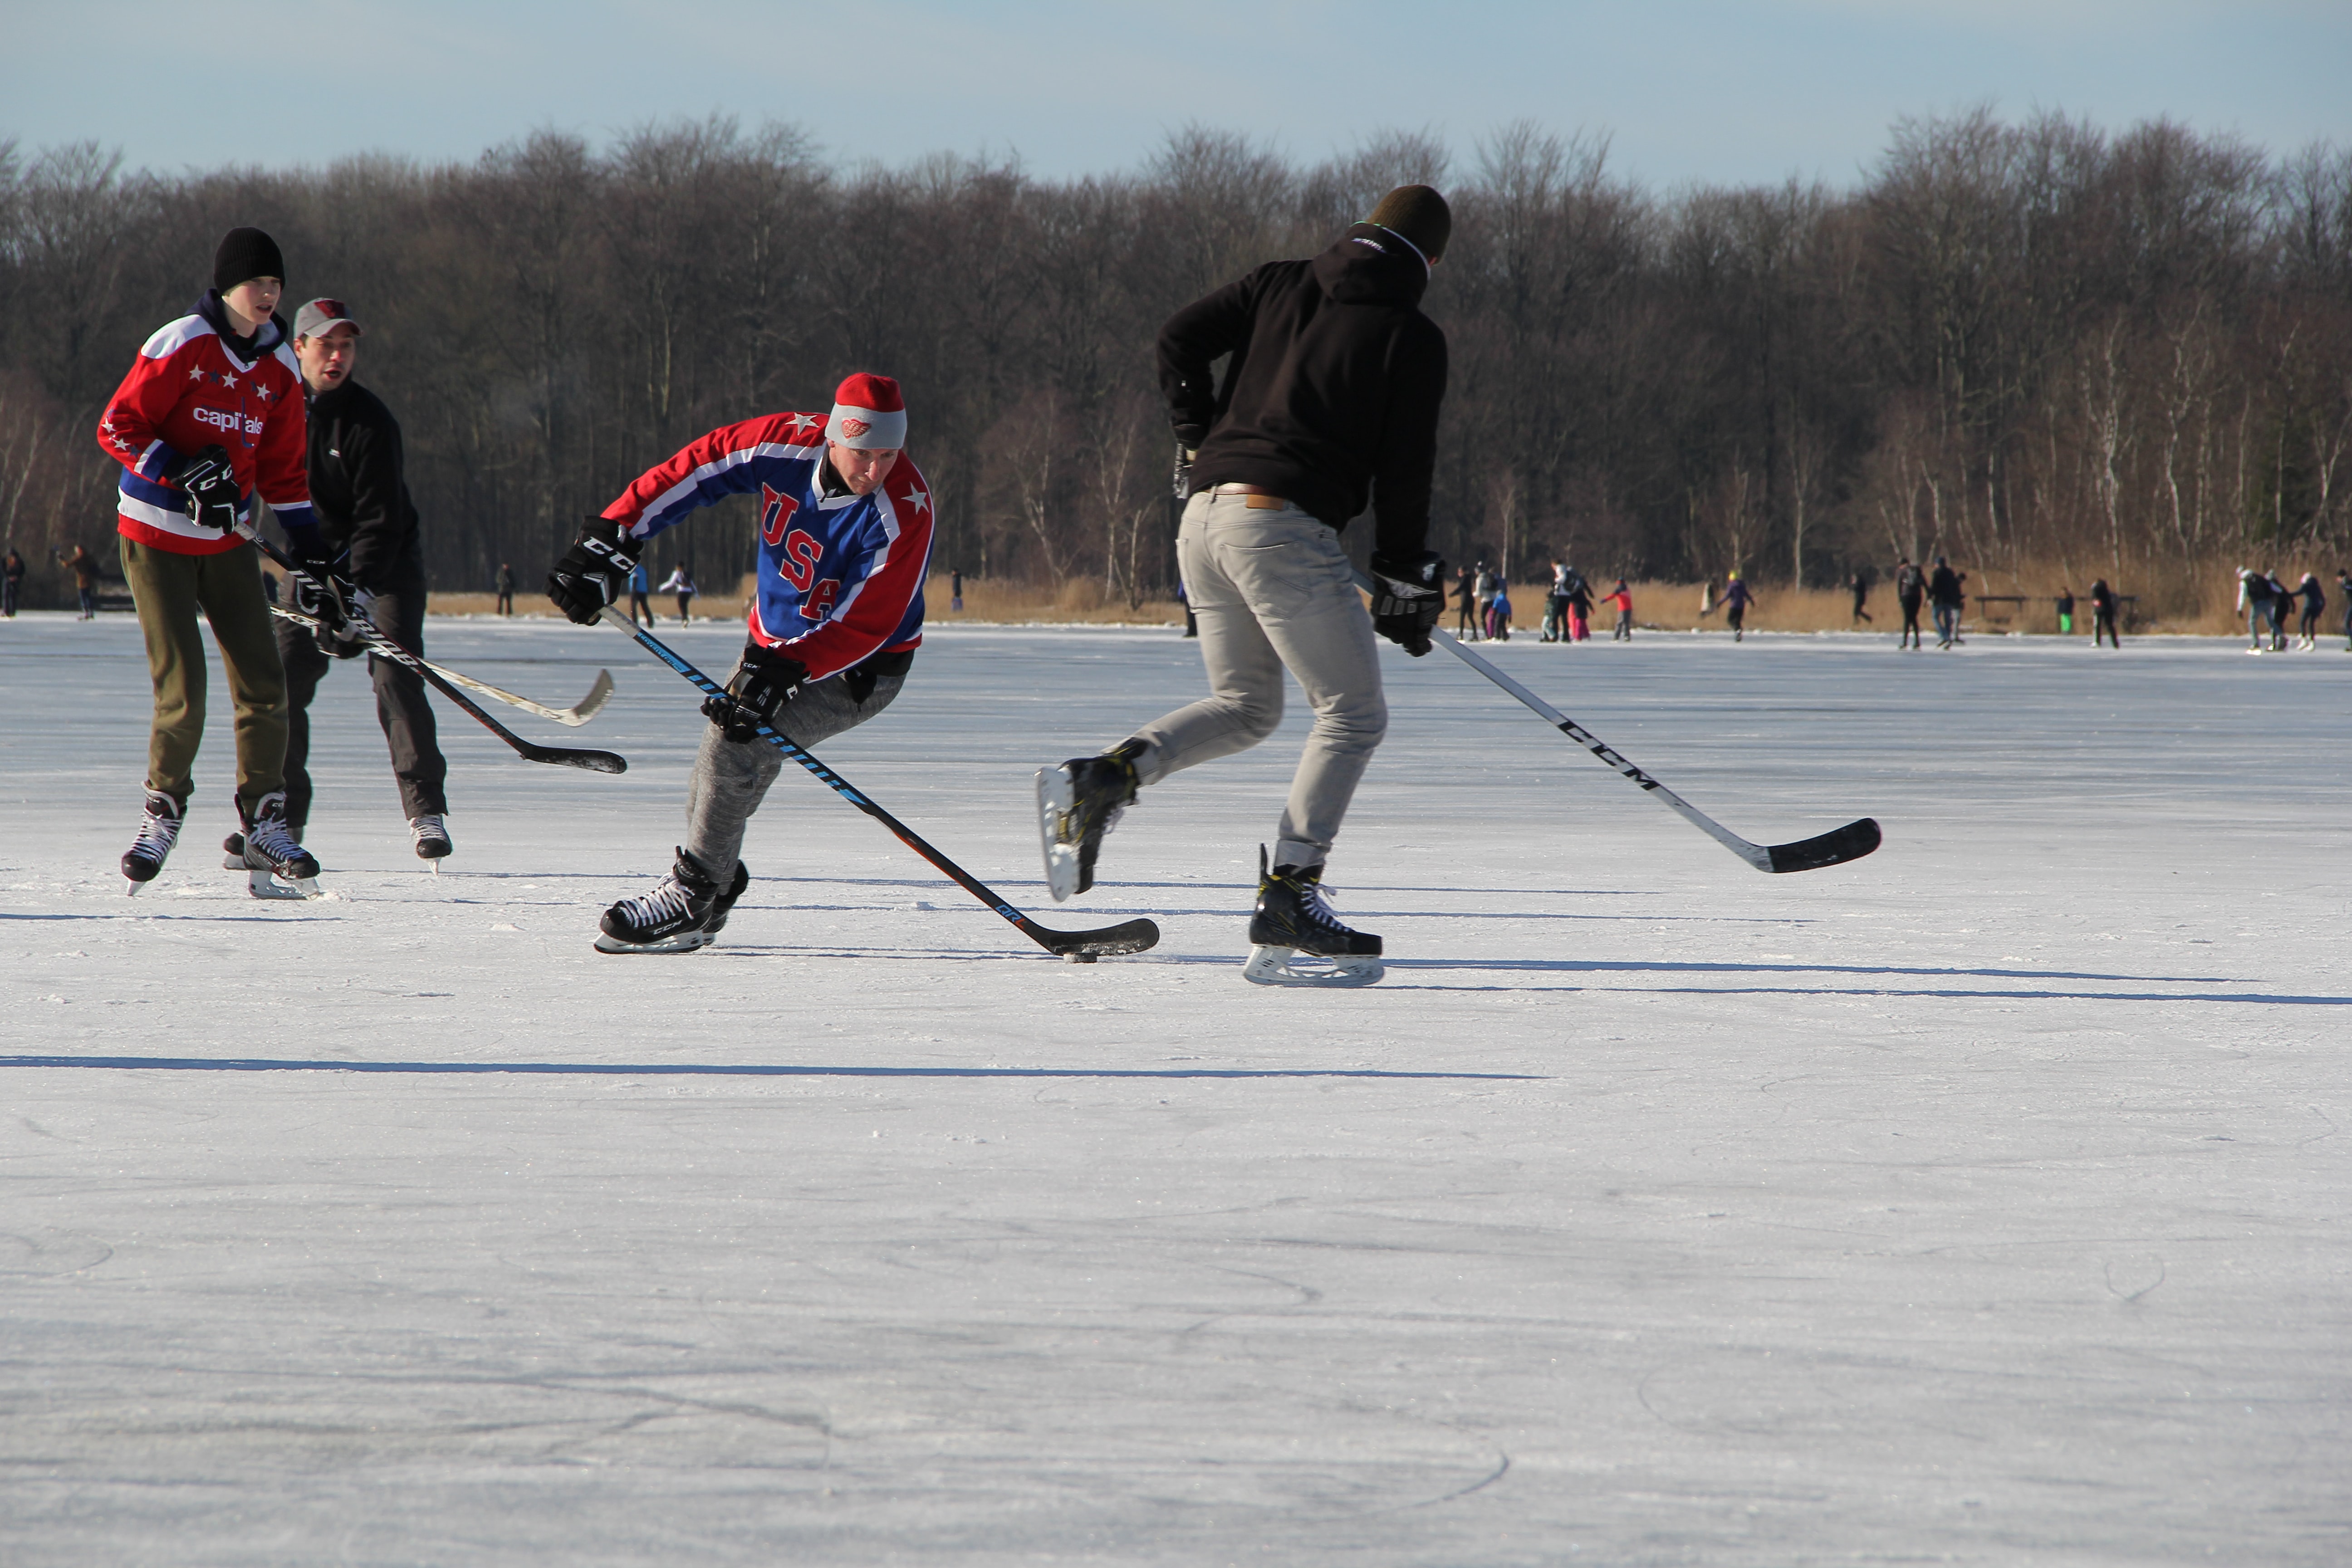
0, 0, 2352, 186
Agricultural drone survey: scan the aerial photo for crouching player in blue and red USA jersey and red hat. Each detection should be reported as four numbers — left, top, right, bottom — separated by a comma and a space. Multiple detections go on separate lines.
548, 374, 931, 952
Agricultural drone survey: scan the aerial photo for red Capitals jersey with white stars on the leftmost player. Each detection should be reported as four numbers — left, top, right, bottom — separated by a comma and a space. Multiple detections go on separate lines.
99, 296, 313, 555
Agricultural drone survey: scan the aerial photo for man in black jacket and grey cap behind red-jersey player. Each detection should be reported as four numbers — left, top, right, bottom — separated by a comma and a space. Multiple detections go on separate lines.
278, 299, 449, 870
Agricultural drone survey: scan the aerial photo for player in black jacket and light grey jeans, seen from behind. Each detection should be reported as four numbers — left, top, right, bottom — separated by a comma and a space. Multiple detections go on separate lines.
1037, 186, 1454, 985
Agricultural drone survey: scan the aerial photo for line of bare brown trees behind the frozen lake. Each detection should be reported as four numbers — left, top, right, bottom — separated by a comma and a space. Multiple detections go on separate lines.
0, 111, 2352, 602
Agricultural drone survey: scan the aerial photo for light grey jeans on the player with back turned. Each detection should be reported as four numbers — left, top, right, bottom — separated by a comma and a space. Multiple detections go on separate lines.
1136, 494, 1388, 865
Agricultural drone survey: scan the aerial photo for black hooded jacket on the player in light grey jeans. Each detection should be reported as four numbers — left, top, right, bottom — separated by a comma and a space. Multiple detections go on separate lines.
1160, 223, 1446, 555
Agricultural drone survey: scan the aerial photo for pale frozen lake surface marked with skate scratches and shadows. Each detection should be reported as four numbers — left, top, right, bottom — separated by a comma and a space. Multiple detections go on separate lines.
0, 616, 2352, 1568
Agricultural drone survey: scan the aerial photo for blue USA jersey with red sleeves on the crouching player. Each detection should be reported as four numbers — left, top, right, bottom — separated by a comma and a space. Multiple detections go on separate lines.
604, 414, 931, 679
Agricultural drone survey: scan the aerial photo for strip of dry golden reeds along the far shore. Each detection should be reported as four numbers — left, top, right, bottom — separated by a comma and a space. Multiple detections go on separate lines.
418, 562, 2342, 642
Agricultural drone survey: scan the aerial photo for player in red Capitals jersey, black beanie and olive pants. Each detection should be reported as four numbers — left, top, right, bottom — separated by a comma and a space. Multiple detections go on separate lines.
99, 228, 324, 896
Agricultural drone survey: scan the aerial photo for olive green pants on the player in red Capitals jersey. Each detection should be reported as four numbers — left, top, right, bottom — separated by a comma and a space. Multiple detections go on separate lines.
122, 539, 287, 811
